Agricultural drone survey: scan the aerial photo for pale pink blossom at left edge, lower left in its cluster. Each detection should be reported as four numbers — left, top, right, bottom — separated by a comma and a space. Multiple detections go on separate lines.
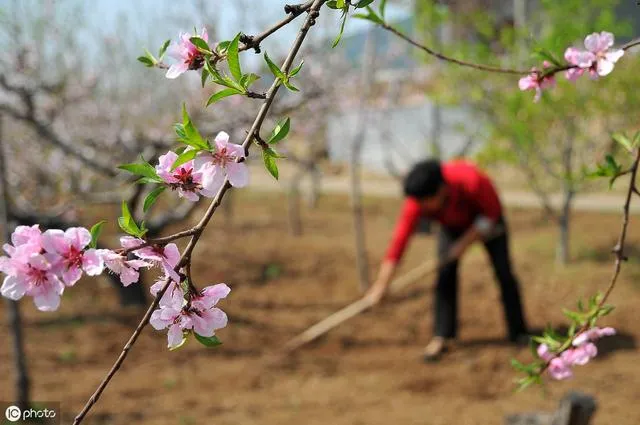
0, 250, 64, 311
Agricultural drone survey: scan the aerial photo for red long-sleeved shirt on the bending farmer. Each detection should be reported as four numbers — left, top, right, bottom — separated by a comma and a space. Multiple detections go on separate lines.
385, 160, 502, 262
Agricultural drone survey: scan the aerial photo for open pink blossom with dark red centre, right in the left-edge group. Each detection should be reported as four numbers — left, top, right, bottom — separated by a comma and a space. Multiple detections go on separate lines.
42, 227, 104, 286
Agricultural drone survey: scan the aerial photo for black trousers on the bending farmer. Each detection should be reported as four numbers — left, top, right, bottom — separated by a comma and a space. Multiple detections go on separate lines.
434, 219, 527, 341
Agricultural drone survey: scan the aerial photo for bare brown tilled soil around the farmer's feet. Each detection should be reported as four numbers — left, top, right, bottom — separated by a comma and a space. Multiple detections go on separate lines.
0, 192, 640, 425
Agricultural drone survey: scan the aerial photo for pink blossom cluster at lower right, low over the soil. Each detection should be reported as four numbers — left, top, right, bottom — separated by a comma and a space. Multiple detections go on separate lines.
538, 327, 616, 380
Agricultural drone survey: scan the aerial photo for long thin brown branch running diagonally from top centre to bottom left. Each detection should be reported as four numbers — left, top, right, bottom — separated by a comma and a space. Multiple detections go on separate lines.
73, 0, 326, 425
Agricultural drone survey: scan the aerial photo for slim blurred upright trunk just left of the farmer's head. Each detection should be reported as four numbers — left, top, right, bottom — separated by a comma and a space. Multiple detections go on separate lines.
349, 30, 375, 291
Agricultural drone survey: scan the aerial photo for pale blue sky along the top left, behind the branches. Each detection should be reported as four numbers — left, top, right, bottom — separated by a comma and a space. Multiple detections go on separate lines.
0, 0, 408, 71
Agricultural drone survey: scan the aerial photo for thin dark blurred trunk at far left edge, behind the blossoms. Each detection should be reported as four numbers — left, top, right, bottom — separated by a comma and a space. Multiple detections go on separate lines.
0, 115, 29, 409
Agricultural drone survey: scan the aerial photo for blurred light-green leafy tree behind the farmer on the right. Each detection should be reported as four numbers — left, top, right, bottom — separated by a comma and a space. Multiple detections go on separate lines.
415, 0, 640, 264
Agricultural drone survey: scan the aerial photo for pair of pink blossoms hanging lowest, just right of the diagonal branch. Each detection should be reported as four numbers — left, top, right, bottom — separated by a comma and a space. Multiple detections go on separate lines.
149, 282, 230, 348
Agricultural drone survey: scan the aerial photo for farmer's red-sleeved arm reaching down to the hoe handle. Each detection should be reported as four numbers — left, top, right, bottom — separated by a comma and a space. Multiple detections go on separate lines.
365, 199, 420, 303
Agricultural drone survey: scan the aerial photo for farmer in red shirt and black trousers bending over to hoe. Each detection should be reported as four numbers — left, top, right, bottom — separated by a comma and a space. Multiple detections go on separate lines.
366, 160, 528, 360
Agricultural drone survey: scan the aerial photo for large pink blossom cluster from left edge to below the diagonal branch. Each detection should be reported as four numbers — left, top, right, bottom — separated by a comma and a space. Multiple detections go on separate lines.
0, 224, 230, 348
